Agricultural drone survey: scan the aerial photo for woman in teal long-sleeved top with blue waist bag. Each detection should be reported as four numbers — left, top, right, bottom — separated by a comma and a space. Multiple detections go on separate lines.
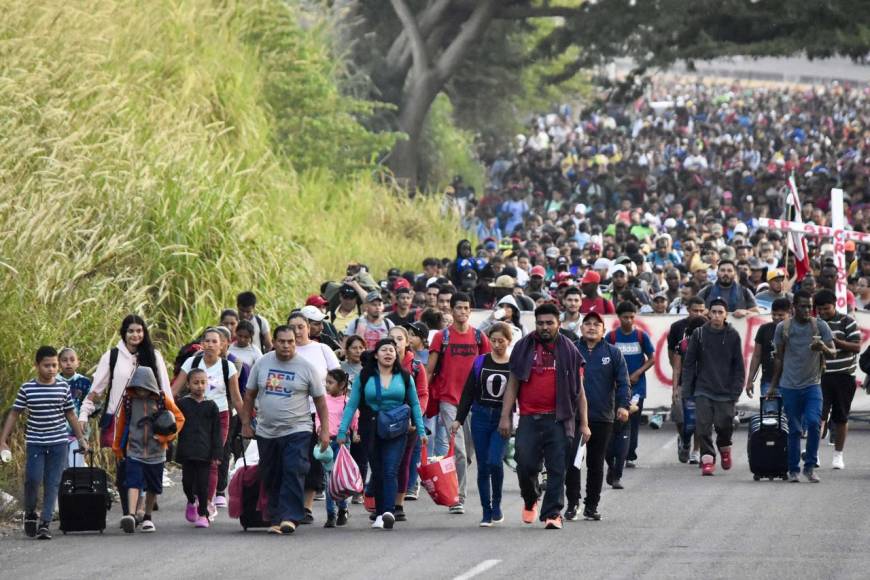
336, 338, 427, 530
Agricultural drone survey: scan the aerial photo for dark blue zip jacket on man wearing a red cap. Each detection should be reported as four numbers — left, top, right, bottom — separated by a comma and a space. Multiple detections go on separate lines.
575, 340, 631, 423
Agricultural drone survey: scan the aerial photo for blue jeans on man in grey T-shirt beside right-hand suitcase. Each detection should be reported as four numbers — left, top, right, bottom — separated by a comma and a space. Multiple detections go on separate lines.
779, 385, 822, 473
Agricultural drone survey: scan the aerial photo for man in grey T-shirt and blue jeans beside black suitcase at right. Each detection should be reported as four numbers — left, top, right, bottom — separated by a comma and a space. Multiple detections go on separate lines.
767, 290, 836, 483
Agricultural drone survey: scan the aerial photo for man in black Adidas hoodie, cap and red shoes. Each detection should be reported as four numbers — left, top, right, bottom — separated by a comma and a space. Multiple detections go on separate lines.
682, 298, 746, 475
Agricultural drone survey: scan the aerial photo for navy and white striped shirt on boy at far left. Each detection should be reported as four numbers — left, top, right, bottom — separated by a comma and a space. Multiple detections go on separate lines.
12, 381, 75, 445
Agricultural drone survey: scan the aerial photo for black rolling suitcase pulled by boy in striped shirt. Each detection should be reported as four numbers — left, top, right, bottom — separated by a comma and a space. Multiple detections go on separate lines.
58, 451, 111, 534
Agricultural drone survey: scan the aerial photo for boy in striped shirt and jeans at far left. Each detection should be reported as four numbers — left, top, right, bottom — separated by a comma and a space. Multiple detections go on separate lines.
0, 346, 88, 540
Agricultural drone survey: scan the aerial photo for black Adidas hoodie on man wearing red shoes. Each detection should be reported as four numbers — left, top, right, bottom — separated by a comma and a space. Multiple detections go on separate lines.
682, 322, 746, 401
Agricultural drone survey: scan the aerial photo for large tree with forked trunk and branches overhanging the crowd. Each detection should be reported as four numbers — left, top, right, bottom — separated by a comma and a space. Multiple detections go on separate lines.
345, 0, 870, 190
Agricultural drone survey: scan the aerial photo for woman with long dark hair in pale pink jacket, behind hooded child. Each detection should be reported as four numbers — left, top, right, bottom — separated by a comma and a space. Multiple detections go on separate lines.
79, 314, 172, 513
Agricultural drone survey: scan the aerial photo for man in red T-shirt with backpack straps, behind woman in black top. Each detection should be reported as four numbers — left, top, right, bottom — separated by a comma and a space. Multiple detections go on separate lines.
426, 292, 492, 514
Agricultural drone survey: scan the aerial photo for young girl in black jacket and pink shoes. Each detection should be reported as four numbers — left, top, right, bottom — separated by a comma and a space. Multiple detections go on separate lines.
175, 368, 223, 528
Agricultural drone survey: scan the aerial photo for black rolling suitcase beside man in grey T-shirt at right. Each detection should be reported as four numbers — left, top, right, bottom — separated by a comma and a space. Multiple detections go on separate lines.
747, 397, 788, 481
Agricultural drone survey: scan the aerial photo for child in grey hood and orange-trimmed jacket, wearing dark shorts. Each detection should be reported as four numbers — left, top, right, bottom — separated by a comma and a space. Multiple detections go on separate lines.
112, 367, 184, 534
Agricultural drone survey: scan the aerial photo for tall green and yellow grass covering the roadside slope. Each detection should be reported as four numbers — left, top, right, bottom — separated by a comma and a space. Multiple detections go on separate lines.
0, 0, 457, 408
